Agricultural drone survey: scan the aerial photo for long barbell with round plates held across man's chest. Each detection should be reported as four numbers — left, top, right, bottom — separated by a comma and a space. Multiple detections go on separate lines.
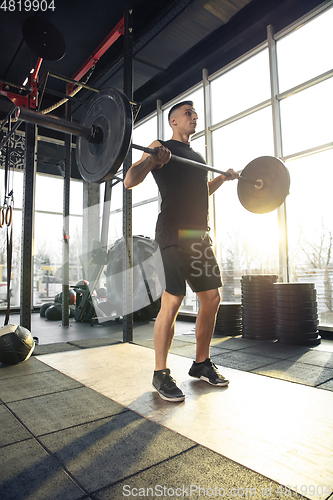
17, 88, 290, 213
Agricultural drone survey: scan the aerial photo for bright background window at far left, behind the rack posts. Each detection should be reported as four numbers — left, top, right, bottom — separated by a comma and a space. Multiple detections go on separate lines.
0, 166, 83, 307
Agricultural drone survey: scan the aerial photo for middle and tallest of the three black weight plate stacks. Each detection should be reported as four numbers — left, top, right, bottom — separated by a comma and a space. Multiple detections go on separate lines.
242, 274, 278, 340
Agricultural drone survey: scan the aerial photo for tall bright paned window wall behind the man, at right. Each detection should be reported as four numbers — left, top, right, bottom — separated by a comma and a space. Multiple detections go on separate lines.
156, 4, 333, 326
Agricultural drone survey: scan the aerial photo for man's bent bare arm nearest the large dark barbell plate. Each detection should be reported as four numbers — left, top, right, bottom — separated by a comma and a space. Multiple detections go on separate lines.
124, 141, 171, 189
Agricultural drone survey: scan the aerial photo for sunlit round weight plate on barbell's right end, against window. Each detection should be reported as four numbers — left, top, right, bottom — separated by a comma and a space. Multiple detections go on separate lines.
237, 156, 290, 214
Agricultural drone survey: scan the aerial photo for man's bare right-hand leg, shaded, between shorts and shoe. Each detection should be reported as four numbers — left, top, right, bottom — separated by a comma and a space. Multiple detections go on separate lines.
195, 289, 221, 363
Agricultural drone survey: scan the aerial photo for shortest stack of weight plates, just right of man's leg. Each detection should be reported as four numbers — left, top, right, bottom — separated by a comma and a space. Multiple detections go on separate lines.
214, 302, 242, 337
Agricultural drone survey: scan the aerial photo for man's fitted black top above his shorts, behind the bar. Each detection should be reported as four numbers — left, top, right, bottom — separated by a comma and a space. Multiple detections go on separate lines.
152, 140, 208, 246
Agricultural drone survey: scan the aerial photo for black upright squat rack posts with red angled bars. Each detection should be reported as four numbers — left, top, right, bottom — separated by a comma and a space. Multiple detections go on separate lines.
0, 7, 133, 342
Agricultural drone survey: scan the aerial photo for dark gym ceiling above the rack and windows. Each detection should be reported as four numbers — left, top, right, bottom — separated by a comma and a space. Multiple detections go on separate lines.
0, 0, 327, 178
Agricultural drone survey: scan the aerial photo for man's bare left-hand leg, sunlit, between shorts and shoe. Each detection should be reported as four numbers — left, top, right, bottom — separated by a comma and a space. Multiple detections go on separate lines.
154, 292, 184, 370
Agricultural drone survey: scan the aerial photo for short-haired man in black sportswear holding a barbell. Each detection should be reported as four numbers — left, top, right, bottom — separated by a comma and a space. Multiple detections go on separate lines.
124, 101, 238, 402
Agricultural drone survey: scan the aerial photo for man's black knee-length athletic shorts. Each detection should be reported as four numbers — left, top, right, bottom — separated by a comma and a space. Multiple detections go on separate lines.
157, 233, 222, 295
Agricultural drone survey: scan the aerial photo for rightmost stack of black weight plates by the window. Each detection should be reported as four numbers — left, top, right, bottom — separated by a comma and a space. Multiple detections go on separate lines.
274, 283, 321, 347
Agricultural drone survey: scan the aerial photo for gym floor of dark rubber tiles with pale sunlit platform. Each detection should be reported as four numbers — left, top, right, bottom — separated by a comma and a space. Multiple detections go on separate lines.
0, 313, 333, 500
